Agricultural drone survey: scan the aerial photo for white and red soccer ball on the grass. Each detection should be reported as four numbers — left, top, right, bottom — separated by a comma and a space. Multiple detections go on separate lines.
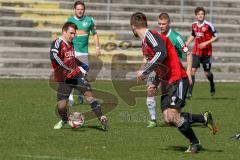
68, 112, 84, 129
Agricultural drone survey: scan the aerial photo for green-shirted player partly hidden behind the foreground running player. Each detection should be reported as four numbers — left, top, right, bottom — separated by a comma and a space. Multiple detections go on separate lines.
144, 13, 192, 128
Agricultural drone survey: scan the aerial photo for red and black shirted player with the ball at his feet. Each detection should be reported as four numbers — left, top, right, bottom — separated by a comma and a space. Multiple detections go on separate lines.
50, 22, 107, 130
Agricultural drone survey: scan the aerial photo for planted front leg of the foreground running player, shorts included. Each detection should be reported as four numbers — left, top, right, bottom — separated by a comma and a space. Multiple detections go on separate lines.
161, 78, 201, 153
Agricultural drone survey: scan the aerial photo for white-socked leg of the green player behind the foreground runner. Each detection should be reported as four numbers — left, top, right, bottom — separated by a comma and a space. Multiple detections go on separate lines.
146, 72, 157, 128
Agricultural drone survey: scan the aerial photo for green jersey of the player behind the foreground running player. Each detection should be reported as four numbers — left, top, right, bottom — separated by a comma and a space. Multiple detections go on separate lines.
166, 28, 189, 61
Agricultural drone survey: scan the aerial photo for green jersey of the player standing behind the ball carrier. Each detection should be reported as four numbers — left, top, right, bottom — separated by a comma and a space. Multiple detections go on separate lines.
67, 16, 97, 55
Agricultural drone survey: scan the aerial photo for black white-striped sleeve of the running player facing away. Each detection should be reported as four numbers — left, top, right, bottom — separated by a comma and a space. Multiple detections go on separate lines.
142, 31, 167, 75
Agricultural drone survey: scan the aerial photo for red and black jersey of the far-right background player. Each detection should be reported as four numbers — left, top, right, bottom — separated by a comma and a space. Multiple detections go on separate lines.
192, 20, 218, 56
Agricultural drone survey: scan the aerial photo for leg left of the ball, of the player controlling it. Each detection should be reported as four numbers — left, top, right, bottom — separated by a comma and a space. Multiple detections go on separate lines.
54, 82, 72, 129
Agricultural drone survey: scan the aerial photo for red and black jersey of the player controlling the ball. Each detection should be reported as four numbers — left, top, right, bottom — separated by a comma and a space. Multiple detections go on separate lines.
50, 37, 77, 82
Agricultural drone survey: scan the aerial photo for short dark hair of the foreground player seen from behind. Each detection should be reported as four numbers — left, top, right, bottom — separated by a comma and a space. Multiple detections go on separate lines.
130, 12, 148, 28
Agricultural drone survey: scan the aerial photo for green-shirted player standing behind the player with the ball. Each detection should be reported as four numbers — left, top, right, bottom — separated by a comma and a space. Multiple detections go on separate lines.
67, 1, 101, 106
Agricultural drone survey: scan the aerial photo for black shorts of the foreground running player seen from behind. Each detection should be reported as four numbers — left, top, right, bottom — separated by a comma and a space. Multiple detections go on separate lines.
161, 78, 189, 111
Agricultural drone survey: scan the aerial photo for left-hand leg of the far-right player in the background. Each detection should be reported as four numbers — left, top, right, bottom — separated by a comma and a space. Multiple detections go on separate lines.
187, 55, 200, 98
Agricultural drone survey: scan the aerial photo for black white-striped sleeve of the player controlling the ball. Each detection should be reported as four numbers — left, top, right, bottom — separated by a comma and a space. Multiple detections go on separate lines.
50, 39, 71, 71
